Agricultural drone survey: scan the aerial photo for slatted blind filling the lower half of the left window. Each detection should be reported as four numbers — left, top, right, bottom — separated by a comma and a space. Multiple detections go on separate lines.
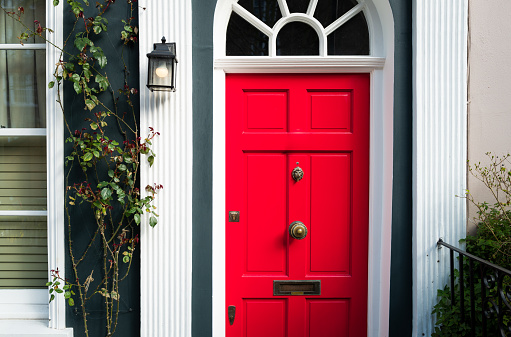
0, 136, 48, 288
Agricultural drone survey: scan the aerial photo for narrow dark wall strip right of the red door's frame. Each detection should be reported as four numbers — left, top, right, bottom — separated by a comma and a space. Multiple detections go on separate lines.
389, 0, 413, 337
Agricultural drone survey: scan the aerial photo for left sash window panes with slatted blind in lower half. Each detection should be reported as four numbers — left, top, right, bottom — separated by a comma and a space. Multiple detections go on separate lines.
0, 0, 48, 289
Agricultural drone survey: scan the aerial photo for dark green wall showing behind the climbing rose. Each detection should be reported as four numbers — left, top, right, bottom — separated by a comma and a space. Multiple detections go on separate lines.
61, 1, 140, 337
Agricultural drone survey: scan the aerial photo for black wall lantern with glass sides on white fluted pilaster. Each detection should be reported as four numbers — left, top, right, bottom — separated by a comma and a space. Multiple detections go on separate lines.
147, 37, 177, 91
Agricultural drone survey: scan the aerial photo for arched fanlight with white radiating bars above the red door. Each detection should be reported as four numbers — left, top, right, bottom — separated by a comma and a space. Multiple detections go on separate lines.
226, 0, 369, 56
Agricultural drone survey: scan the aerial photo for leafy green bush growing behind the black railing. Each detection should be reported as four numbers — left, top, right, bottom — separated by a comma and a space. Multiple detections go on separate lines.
432, 153, 511, 337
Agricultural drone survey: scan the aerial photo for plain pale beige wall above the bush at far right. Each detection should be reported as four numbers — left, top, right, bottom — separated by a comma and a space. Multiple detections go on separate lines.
467, 0, 511, 232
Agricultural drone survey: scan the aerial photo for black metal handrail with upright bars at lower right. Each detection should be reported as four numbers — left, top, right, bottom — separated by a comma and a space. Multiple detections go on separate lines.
437, 239, 511, 337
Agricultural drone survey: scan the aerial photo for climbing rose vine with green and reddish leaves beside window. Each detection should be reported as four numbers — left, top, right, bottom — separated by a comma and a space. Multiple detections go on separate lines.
0, 0, 158, 336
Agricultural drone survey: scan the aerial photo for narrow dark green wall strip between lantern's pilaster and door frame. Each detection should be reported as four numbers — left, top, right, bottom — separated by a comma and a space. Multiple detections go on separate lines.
192, 0, 216, 337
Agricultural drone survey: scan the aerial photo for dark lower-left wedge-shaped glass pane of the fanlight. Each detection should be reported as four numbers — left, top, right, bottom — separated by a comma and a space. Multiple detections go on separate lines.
226, 12, 268, 56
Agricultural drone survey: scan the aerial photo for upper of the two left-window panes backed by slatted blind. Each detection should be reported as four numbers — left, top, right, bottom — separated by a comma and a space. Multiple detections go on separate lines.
0, 136, 46, 211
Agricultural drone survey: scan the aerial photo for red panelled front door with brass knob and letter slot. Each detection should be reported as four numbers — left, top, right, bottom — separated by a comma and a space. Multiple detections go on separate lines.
225, 74, 370, 337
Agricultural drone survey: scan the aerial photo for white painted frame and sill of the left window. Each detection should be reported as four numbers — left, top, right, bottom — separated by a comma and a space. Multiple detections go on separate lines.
0, 0, 68, 336
